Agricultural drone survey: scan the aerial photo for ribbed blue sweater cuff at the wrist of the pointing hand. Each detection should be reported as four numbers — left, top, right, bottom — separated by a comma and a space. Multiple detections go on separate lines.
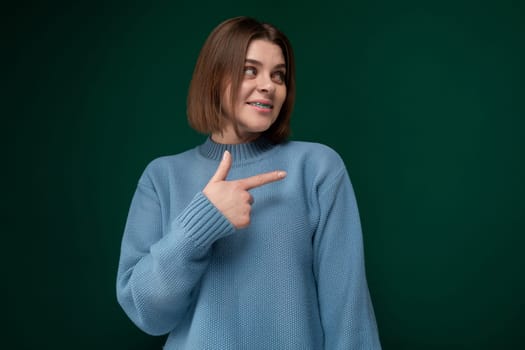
177, 192, 235, 247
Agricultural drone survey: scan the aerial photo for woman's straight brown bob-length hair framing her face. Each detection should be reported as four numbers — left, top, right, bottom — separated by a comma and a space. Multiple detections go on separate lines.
187, 16, 295, 143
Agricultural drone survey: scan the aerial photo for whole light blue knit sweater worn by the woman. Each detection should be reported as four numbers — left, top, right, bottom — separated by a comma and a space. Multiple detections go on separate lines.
117, 138, 381, 350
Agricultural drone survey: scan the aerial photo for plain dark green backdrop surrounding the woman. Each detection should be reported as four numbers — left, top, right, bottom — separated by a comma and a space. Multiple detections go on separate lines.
5, 0, 525, 350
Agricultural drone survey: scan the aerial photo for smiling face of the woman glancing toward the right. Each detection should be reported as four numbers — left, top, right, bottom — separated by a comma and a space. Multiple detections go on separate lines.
212, 39, 286, 143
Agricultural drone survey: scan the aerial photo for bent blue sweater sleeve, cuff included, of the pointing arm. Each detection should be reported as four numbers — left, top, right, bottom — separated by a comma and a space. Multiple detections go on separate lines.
117, 174, 234, 335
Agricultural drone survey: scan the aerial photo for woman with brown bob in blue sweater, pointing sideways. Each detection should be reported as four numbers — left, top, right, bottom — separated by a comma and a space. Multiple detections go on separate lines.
117, 17, 380, 350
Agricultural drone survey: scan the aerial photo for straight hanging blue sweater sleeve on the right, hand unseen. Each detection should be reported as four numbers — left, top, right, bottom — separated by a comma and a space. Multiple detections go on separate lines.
314, 166, 381, 350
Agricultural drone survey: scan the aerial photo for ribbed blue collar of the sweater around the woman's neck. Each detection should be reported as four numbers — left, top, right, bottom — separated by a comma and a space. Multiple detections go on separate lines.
199, 137, 275, 164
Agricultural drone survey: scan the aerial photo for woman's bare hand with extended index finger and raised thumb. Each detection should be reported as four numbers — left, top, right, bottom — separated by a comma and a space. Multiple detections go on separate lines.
202, 151, 286, 229
